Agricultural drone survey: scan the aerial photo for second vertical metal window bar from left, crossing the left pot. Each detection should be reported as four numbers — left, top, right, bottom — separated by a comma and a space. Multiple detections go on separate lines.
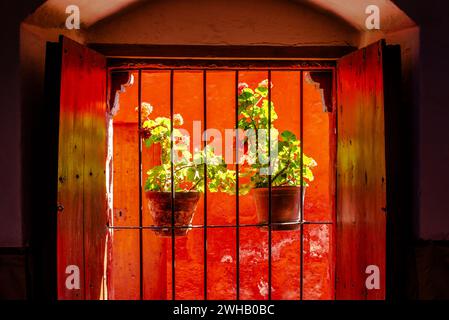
170, 69, 176, 300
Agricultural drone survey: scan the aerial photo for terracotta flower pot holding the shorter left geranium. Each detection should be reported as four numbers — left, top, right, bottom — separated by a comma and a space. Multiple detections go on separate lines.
146, 191, 200, 237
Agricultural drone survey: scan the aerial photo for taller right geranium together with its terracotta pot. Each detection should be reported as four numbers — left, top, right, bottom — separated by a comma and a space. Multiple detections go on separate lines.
234, 80, 317, 230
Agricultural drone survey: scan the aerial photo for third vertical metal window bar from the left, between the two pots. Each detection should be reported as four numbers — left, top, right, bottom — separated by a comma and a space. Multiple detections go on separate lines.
203, 70, 207, 300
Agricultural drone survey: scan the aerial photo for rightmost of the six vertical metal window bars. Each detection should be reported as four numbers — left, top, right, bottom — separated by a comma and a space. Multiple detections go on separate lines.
299, 70, 304, 300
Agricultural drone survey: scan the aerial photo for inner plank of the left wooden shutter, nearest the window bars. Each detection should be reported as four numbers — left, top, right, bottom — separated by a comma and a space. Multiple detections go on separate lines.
83, 44, 108, 300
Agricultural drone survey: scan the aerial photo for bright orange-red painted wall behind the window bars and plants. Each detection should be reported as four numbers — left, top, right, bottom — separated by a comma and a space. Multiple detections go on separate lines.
109, 71, 334, 299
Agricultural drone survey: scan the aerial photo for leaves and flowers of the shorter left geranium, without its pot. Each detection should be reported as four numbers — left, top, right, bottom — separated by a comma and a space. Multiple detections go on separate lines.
141, 103, 235, 192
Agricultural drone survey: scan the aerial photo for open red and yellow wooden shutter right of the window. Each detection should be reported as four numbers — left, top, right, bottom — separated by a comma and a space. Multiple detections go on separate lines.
336, 42, 386, 300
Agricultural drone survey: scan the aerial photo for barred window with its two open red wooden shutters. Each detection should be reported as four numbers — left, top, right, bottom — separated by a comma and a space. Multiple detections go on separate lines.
54, 38, 386, 300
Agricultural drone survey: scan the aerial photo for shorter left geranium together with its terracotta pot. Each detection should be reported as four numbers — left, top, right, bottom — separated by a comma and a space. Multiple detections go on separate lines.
141, 103, 235, 237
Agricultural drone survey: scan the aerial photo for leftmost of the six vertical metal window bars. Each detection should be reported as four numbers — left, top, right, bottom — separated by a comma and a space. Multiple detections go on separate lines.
137, 69, 144, 300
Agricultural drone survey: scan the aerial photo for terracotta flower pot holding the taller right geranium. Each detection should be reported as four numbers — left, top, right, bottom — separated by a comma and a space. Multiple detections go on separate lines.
253, 187, 305, 230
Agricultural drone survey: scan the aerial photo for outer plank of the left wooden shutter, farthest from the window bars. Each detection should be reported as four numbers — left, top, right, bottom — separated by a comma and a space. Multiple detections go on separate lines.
57, 37, 85, 299
